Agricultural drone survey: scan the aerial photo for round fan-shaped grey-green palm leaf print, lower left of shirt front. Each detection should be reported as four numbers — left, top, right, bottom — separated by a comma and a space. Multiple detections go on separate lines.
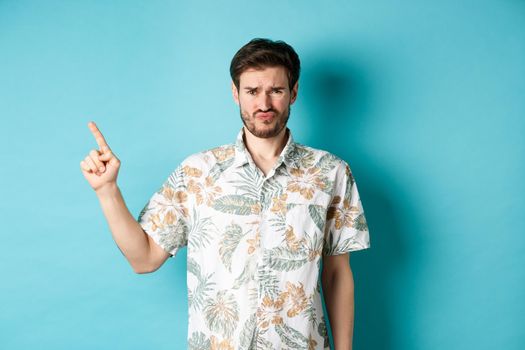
204, 290, 239, 338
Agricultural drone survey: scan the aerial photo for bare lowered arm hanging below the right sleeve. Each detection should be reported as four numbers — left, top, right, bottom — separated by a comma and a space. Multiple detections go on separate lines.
323, 267, 354, 350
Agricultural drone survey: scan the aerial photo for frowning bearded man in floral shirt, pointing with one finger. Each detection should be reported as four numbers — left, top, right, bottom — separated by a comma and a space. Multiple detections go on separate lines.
80, 39, 370, 350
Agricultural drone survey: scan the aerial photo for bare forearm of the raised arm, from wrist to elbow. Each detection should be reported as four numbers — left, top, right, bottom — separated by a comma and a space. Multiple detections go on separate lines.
96, 184, 150, 272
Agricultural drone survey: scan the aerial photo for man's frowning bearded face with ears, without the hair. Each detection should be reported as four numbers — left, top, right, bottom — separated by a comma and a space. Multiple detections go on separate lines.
232, 67, 298, 138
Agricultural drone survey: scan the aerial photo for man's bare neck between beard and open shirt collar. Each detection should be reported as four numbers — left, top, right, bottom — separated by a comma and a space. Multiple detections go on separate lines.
244, 127, 288, 163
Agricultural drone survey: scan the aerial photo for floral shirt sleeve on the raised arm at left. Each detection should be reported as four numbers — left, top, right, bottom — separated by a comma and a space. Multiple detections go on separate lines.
137, 166, 189, 256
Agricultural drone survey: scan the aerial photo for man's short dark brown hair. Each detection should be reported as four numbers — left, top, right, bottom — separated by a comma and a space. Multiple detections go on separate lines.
230, 38, 301, 90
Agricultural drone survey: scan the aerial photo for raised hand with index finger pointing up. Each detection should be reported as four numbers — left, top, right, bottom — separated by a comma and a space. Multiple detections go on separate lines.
80, 122, 120, 192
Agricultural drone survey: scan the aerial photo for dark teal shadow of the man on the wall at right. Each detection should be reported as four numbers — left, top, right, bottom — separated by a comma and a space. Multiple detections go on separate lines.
302, 56, 409, 349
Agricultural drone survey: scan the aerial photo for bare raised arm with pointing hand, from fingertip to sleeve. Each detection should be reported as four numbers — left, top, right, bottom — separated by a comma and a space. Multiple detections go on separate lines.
80, 122, 169, 273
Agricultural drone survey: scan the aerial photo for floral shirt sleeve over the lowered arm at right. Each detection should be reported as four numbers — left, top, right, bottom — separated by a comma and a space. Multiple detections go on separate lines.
323, 161, 370, 255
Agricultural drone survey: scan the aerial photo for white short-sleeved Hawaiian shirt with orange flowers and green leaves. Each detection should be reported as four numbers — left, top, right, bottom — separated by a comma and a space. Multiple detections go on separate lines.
138, 129, 370, 350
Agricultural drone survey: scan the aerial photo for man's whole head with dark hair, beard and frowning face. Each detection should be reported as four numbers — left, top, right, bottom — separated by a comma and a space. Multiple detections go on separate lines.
230, 39, 300, 138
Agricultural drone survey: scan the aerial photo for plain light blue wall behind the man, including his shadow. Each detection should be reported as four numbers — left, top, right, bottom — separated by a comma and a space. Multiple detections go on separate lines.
0, 0, 525, 350
